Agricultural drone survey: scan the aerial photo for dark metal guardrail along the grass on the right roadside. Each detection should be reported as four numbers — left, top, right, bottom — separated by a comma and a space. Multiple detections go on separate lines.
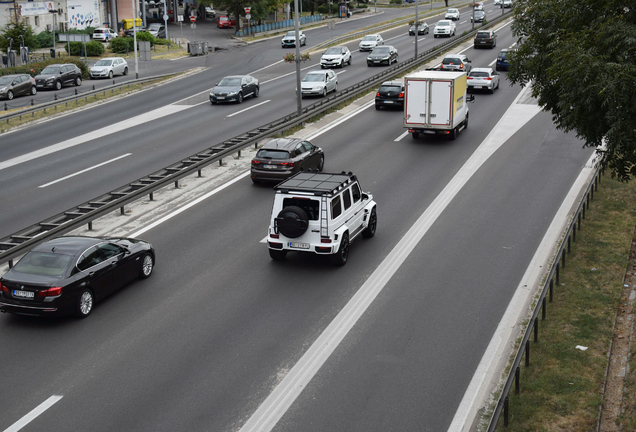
487, 167, 602, 432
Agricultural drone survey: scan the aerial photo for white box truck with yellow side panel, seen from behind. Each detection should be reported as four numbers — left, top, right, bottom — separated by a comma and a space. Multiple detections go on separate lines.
404, 70, 475, 140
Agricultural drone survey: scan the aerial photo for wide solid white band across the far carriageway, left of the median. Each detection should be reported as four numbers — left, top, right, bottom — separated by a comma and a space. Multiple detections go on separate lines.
0, 105, 190, 170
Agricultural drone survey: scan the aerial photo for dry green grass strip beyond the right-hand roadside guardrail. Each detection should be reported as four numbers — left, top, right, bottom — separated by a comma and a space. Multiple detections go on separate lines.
497, 175, 636, 432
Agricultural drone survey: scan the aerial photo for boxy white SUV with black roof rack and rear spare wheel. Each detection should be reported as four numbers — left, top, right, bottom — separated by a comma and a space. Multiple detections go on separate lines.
267, 172, 378, 266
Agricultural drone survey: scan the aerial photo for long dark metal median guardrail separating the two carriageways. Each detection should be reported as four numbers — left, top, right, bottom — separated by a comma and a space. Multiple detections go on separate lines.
0, 10, 507, 267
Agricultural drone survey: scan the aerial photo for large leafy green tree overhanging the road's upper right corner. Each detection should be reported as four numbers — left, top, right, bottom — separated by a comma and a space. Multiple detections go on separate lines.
508, 0, 636, 181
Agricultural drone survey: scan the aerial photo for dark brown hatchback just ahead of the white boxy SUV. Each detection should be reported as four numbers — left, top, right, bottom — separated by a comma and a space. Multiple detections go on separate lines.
251, 138, 325, 183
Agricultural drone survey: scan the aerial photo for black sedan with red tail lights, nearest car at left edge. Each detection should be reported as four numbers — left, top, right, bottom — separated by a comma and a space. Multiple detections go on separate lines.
0, 237, 155, 318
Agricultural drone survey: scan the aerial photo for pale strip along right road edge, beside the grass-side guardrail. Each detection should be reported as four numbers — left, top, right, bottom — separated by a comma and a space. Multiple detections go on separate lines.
448, 153, 596, 432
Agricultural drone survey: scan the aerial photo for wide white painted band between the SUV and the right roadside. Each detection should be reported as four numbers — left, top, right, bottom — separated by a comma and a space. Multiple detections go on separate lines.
239, 90, 540, 432
